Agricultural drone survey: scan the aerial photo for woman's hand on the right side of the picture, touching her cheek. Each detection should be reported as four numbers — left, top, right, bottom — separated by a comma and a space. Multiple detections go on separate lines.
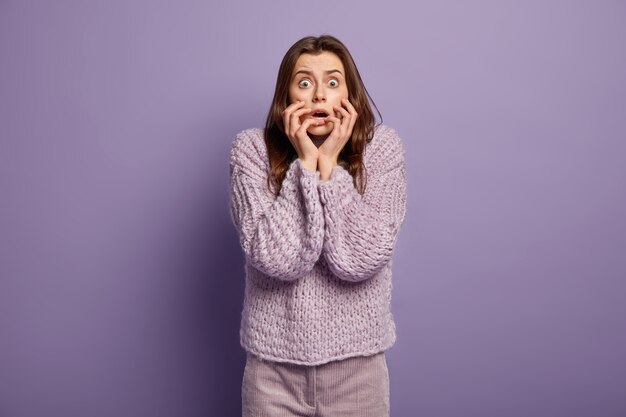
318, 98, 358, 180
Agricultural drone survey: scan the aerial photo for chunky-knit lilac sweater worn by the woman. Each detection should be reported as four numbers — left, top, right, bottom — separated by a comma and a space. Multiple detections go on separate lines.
230, 125, 406, 365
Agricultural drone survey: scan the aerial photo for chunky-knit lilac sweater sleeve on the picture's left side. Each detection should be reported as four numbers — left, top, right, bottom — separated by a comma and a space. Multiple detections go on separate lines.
230, 131, 324, 281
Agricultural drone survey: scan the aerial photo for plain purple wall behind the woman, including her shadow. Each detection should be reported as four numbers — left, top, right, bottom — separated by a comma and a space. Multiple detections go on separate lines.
0, 0, 626, 417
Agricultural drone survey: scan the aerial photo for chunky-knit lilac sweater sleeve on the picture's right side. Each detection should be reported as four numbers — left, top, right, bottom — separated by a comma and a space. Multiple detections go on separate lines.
318, 126, 406, 281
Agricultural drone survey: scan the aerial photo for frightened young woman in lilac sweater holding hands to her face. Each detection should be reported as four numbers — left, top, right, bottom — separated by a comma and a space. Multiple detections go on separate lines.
230, 35, 406, 417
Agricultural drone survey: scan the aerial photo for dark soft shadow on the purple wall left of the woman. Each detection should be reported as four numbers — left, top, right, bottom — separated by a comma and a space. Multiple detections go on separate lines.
166, 114, 254, 417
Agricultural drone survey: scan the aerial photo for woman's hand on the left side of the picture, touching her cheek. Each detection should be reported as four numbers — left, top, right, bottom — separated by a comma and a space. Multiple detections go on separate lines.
283, 101, 323, 171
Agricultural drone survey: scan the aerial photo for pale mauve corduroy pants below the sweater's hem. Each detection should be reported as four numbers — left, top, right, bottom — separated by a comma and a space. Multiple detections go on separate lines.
241, 352, 389, 417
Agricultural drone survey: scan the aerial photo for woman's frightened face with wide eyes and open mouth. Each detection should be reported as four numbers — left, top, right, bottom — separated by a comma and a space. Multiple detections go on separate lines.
289, 51, 348, 136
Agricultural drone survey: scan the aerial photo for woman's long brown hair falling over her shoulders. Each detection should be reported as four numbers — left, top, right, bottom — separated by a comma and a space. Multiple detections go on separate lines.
264, 35, 382, 195
